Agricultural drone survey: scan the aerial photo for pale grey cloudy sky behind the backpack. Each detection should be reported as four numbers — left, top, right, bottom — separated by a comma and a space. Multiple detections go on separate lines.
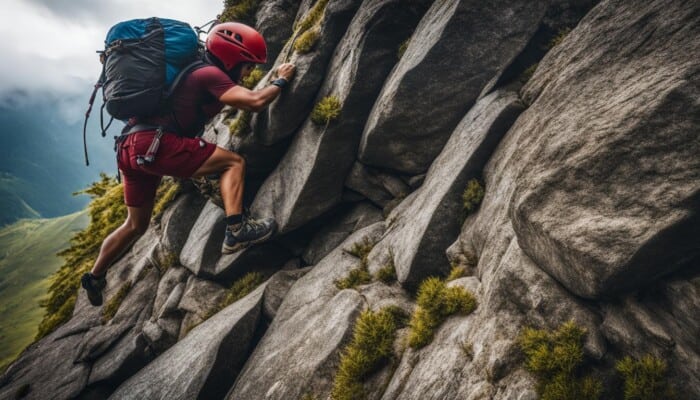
0, 0, 223, 120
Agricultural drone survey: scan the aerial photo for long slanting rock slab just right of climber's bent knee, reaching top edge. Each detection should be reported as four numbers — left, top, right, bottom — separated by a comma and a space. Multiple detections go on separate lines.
252, 0, 420, 233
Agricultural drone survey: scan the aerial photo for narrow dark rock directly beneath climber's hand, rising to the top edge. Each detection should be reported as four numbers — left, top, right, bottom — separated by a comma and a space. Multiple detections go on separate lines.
251, 0, 361, 145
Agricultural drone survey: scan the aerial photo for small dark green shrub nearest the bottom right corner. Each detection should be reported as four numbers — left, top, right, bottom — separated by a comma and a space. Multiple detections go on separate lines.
615, 354, 675, 400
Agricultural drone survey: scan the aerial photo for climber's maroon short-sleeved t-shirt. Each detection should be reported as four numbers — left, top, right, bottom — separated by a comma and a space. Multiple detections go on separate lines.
140, 65, 236, 137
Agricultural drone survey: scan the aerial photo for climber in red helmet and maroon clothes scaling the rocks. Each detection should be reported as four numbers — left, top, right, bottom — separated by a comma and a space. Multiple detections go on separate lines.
81, 22, 295, 306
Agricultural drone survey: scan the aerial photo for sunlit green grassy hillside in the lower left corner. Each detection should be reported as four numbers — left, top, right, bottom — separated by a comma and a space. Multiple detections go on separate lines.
0, 211, 88, 371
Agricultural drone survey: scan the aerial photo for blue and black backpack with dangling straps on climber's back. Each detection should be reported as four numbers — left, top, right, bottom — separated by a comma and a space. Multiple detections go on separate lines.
83, 17, 206, 165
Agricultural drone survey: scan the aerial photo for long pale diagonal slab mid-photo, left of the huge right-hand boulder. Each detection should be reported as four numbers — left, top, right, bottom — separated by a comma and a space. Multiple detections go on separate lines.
370, 91, 523, 288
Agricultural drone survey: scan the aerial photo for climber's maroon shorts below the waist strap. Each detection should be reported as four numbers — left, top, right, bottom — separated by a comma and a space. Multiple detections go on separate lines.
117, 131, 216, 207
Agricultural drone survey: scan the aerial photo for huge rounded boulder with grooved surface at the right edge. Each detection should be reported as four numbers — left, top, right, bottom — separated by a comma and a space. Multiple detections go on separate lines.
512, 1, 700, 298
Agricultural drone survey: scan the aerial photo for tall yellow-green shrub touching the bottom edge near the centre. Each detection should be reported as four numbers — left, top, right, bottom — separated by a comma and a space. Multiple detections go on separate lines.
331, 307, 402, 400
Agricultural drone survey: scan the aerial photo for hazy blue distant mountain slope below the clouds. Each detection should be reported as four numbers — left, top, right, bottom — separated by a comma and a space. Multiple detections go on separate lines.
0, 101, 117, 221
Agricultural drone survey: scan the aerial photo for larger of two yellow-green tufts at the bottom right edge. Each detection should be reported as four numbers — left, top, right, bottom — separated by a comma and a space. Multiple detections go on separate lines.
518, 321, 602, 400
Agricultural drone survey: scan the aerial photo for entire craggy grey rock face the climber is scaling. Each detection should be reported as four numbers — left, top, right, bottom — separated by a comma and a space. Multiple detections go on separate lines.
0, 0, 700, 400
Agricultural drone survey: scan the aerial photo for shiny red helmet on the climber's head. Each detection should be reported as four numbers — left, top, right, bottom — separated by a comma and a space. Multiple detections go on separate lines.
207, 22, 267, 70
